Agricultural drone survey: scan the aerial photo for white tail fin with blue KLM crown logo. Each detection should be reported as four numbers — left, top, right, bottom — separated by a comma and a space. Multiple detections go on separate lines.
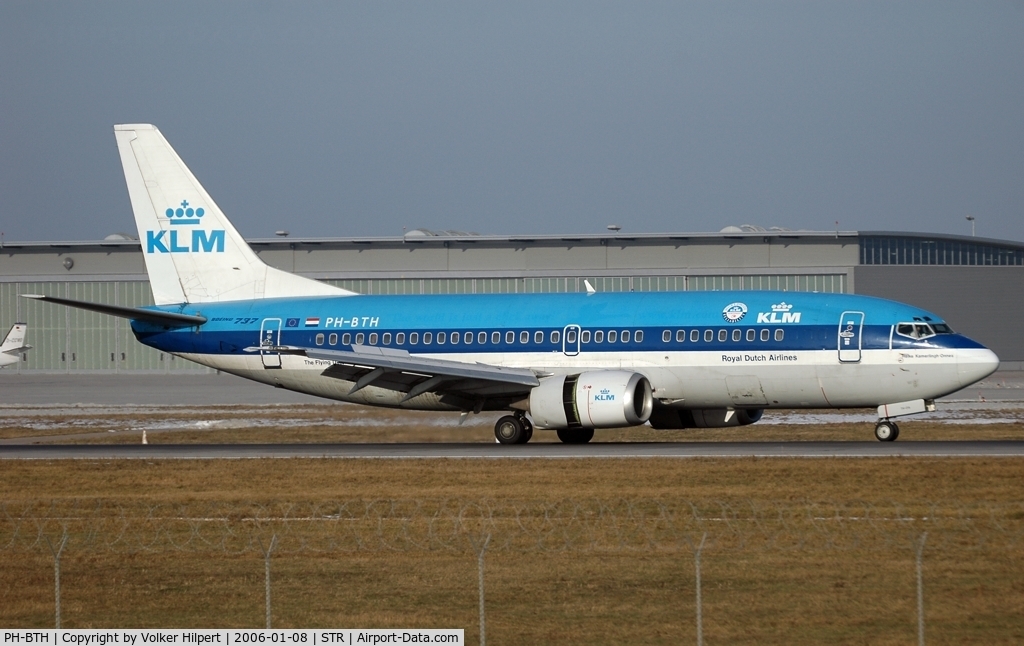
114, 124, 353, 305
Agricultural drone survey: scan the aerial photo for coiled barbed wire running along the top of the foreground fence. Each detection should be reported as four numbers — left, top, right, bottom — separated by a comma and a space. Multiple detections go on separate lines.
0, 499, 1024, 554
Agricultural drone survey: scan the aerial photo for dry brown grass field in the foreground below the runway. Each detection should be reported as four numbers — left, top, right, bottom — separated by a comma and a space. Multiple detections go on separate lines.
0, 454, 1024, 644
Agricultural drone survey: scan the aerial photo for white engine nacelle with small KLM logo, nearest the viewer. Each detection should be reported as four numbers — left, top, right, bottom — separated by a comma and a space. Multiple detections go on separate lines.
529, 371, 654, 429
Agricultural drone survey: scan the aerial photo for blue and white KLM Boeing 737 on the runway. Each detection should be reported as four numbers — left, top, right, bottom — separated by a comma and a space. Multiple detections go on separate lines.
23, 124, 998, 444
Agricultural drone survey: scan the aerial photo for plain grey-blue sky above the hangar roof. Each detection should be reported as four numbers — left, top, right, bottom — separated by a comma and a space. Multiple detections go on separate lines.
0, 0, 1024, 242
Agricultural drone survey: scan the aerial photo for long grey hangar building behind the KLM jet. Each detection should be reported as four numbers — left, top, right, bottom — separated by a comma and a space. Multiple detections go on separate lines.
0, 231, 1024, 373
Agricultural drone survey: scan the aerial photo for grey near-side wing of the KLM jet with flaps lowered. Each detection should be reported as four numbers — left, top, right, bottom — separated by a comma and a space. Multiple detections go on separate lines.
304, 345, 541, 402
